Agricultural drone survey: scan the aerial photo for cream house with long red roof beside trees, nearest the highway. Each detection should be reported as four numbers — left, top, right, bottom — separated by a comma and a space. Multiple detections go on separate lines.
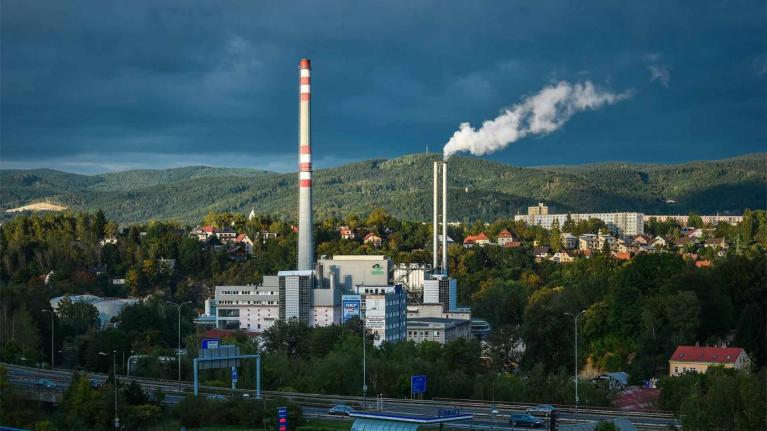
668, 346, 750, 376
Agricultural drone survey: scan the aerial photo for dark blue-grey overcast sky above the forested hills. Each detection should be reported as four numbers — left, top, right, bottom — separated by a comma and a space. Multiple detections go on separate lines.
0, 0, 767, 173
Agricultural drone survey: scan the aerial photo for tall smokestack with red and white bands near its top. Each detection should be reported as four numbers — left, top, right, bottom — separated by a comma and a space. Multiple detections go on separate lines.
298, 58, 314, 271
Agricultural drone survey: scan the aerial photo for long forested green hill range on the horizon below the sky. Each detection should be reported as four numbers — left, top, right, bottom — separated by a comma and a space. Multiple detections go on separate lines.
0, 153, 767, 223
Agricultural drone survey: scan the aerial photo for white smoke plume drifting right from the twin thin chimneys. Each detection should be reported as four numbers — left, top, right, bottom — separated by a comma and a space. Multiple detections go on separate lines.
443, 81, 631, 159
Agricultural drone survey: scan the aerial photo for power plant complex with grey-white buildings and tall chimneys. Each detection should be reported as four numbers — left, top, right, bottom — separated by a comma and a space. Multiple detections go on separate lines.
206, 59, 472, 346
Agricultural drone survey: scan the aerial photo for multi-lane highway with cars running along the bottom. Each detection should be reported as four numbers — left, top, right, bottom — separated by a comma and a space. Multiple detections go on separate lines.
4, 364, 676, 430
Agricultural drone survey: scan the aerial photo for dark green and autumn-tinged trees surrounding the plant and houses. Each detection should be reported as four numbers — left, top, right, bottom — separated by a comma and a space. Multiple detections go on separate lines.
0, 209, 767, 428
